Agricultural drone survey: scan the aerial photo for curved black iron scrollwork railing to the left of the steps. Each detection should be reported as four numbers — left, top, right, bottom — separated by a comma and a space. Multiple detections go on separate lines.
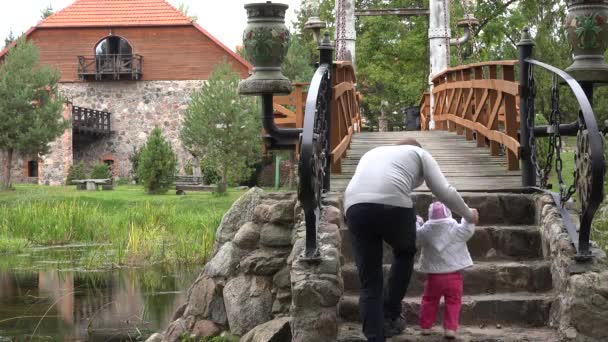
298, 64, 331, 260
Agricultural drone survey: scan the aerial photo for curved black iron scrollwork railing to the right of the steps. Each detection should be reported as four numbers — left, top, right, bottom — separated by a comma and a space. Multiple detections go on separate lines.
524, 58, 605, 261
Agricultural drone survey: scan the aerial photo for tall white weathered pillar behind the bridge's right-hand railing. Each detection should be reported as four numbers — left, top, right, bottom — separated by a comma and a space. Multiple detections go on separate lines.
429, 0, 451, 130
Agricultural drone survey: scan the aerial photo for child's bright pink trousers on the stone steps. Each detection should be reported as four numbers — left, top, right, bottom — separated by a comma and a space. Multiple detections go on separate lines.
420, 272, 462, 330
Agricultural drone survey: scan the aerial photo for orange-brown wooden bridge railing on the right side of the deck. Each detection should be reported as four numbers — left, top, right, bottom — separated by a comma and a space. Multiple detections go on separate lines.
430, 60, 519, 170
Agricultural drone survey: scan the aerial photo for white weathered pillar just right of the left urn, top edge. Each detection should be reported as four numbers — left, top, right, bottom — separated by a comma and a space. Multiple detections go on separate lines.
335, 0, 357, 66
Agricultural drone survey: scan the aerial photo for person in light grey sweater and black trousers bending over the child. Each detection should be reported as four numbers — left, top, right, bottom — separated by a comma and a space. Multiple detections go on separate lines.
344, 138, 479, 342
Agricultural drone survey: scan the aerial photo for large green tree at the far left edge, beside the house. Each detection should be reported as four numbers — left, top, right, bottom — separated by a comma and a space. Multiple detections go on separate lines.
0, 38, 68, 189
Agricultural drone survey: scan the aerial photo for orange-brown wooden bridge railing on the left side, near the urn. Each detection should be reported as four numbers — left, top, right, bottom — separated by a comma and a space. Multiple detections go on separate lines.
273, 61, 361, 173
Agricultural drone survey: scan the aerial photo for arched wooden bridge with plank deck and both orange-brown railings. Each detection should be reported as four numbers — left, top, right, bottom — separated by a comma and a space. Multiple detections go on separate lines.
274, 61, 521, 192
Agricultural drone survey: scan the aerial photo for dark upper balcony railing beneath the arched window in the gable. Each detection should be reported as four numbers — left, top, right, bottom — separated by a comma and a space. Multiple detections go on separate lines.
78, 54, 143, 81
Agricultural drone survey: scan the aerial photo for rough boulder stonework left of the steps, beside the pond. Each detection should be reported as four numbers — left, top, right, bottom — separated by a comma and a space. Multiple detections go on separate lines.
148, 188, 343, 342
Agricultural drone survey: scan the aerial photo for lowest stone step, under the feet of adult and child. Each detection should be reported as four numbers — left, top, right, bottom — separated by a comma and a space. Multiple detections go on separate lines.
338, 322, 559, 342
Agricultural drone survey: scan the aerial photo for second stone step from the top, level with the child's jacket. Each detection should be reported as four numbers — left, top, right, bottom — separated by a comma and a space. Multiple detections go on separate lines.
340, 226, 542, 264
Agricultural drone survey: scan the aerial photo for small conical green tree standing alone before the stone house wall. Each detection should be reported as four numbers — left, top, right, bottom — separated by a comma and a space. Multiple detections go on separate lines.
137, 127, 177, 194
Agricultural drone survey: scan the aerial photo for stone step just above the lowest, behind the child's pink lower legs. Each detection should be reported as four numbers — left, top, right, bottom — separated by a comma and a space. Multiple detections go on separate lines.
338, 292, 553, 327
